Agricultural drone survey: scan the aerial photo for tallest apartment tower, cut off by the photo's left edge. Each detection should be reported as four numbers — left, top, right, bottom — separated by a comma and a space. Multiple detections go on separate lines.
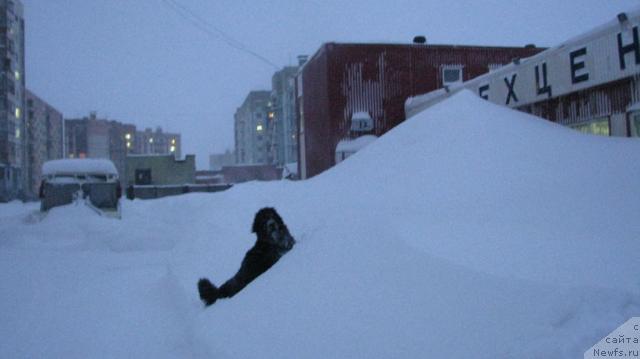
0, 0, 28, 201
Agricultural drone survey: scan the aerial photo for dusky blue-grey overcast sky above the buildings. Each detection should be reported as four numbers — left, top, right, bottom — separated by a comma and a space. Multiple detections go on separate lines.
23, 0, 639, 169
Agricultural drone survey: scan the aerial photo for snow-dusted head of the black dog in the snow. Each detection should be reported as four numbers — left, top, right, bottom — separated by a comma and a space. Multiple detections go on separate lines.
252, 207, 296, 251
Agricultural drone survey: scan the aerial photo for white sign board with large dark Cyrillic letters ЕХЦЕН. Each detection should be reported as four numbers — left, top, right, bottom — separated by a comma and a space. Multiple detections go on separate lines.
463, 13, 640, 107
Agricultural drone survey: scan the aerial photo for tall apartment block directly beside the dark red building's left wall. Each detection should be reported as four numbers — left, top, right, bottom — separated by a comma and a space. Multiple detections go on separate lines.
267, 66, 298, 165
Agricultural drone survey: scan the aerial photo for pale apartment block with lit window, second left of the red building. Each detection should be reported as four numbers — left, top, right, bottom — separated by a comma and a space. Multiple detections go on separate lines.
234, 91, 271, 164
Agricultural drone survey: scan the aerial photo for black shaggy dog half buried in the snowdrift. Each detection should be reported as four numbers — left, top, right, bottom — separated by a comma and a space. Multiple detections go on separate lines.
198, 207, 296, 306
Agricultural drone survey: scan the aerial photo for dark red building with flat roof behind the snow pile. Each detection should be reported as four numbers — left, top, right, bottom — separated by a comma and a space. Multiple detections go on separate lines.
296, 43, 544, 179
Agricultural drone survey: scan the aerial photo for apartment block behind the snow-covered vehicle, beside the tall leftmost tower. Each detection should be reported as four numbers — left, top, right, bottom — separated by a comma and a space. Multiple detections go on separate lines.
26, 90, 64, 197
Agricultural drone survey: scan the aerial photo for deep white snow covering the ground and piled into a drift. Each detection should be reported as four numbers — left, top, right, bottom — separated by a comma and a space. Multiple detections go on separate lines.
0, 92, 640, 358
